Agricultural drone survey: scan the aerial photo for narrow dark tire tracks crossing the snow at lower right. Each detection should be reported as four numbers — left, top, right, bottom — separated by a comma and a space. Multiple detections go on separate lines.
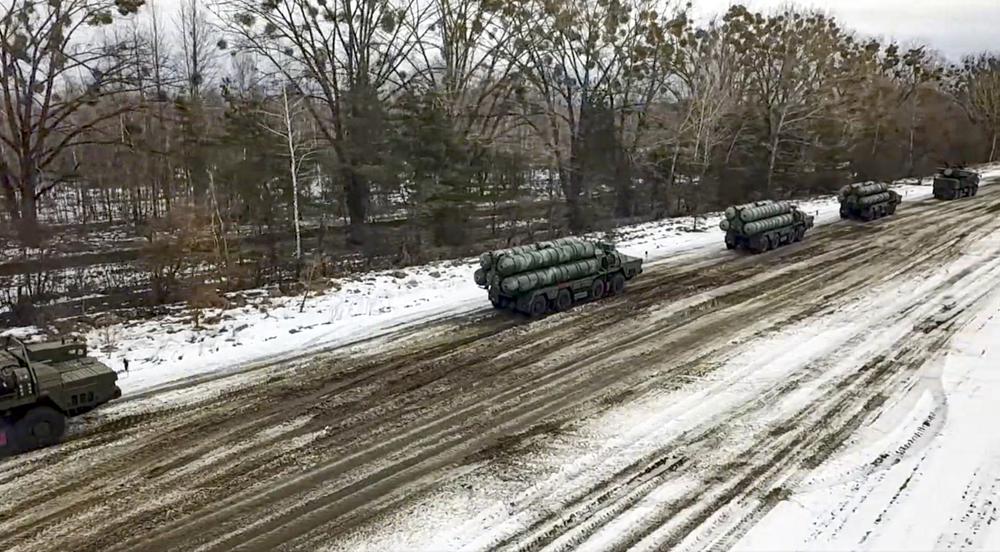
512, 300, 980, 551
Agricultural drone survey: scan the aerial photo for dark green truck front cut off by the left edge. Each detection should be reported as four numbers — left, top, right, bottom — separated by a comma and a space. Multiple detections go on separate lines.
0, 337, 122, 457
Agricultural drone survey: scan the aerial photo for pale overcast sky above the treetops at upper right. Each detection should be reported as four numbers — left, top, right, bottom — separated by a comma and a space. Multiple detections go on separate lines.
692, 0, 1000, 61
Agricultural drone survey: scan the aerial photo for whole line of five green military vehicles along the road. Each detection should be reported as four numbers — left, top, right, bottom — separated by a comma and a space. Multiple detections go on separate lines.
0, 167, 979, 457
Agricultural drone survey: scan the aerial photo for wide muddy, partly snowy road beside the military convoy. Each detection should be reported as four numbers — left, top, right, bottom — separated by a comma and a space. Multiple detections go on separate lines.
0, 186, 1000, 552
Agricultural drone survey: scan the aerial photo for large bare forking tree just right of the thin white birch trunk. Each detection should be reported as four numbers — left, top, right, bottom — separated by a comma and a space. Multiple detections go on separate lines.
218, 0, 429, 243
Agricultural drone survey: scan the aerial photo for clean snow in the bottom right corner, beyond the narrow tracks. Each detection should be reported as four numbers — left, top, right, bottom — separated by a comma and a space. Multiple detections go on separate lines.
736, 231, 1000, 551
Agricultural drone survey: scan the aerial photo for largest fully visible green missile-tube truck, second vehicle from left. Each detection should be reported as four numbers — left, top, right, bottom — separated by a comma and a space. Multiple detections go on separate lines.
474, 238, 642, 317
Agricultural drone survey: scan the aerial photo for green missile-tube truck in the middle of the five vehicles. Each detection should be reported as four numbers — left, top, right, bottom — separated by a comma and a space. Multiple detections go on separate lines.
719, 200, 813, 253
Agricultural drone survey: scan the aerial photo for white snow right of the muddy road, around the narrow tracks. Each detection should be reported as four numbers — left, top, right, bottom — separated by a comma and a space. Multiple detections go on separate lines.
331, 189, 1000, 551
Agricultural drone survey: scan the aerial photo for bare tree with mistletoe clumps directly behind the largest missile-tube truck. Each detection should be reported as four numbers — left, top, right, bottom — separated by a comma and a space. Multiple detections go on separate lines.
507, 0, 686, 231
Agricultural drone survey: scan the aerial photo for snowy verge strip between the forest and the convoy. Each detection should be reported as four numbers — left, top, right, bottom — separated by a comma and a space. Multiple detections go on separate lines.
1, 168, 1000, 394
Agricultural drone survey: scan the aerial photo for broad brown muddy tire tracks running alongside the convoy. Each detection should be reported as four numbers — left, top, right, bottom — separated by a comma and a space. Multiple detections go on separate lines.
0, 183, 996, 549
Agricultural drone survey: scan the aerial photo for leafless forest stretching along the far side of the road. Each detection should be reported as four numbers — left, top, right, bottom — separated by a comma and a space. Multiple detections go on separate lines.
0, 0, 1000, 323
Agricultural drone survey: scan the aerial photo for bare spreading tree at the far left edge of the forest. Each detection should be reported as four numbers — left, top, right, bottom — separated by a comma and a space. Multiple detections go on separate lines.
0, 0, 142, 236
